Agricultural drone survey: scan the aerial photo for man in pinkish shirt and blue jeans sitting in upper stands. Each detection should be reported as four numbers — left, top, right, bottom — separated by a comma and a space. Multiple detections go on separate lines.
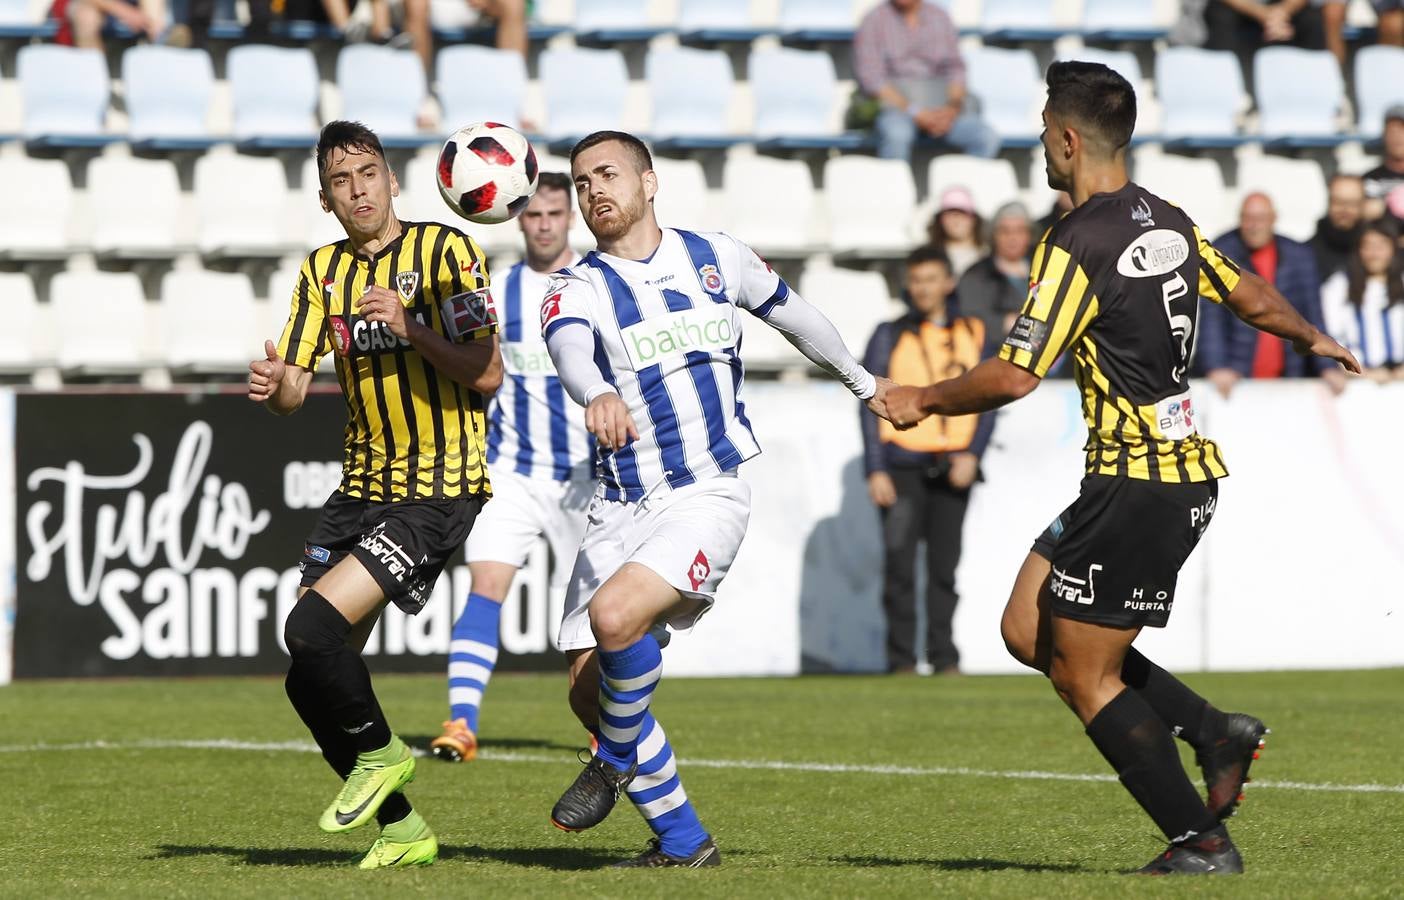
854, 0, 1000, 159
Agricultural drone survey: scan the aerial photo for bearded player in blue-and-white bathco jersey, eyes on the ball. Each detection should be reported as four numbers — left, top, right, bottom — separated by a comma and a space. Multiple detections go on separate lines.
541, 132, 889, 868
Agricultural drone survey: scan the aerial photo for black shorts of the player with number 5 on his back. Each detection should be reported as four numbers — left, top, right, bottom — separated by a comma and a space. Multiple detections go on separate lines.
1032, 475, 1219, 628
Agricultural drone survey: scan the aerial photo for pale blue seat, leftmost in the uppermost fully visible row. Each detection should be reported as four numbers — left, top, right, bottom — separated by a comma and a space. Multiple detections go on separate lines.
15, 44, 110, 146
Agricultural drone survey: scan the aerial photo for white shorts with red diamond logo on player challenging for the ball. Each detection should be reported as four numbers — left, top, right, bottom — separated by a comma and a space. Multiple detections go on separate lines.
558, 472, 751, 650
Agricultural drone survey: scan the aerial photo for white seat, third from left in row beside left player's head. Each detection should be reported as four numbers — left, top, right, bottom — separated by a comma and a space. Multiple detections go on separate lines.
195, 152, 296, 258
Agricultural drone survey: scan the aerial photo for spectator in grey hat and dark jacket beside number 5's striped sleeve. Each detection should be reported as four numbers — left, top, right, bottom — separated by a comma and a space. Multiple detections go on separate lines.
956, 202, 1033, 340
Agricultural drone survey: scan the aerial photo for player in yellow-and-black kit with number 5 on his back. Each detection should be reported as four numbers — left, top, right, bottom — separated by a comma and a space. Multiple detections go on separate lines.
887, 62, 1359, 875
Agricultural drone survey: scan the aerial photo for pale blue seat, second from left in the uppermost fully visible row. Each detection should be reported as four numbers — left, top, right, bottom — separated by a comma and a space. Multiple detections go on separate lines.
122, 44, 215, 149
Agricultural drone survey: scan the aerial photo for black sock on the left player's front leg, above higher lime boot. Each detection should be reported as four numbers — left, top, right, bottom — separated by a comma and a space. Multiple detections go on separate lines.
284, 591, 390, 753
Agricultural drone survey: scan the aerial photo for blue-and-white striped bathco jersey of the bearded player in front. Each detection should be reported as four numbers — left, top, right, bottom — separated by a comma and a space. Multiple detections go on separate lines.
541, 229, 789, 501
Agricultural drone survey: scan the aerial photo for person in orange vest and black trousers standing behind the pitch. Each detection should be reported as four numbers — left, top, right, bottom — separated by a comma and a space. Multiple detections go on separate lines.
862, 247, 994, 674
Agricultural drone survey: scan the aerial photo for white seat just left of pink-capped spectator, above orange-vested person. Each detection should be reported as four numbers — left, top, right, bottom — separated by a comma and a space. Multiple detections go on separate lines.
824, 154, 917, 257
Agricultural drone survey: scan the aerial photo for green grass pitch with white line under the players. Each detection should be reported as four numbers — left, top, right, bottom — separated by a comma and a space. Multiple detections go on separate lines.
0, 670, 1404, 900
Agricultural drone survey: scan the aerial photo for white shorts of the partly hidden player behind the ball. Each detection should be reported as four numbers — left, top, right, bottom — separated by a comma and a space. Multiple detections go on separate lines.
463, 466, 595, 588
